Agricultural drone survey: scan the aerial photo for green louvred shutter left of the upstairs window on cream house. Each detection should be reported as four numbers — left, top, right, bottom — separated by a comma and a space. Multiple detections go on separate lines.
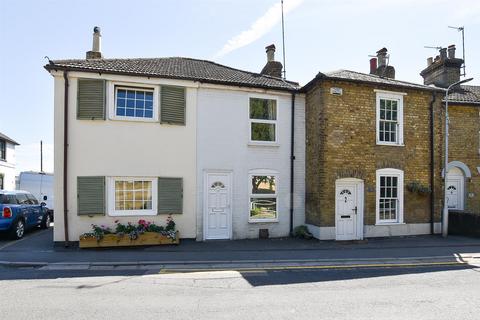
77, 79, 106, 120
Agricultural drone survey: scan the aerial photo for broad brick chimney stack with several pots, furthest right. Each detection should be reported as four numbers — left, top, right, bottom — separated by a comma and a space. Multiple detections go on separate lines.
420, 45, 463, 88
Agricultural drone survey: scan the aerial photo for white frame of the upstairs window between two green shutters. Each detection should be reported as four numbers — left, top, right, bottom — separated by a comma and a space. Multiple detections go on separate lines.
107, 81, 160, 122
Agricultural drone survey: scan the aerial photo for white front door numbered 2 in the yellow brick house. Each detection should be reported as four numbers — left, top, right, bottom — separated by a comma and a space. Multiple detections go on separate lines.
335, 179, 363, 240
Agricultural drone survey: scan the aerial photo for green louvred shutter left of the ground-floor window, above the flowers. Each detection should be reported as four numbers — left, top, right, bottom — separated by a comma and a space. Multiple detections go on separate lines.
77, 177, 106, 216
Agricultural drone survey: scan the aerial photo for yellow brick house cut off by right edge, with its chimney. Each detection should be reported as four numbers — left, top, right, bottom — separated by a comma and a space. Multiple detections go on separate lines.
420, 45, 480, 213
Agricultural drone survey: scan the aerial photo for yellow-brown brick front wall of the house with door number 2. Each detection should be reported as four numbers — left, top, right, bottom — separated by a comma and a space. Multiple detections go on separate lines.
306, 80, 443, 227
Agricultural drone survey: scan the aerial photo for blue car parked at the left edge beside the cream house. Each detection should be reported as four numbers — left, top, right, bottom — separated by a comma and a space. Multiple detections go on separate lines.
0, 190, 51, 239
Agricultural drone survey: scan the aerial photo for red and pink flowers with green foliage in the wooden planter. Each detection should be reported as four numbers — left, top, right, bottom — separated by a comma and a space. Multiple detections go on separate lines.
80, 216, 176, 241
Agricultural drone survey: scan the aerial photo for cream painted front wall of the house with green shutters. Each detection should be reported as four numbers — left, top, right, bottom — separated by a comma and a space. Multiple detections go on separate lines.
53, 72, 197, 241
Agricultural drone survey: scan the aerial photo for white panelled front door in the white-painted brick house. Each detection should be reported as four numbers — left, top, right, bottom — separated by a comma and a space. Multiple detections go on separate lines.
204, 172, 232, 239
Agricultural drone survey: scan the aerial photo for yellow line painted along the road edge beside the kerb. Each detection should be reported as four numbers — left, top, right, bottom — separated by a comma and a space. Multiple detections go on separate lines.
159, 261, 469, 274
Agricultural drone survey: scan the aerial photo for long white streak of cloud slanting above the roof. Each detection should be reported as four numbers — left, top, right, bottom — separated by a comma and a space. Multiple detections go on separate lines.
214, 0, 303, 59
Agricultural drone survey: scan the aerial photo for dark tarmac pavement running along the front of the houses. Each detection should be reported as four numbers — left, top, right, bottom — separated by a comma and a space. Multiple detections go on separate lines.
0, 228, 480, 273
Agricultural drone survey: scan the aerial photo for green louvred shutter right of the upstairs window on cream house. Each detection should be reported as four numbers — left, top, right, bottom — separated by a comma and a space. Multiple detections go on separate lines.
160, 86, 186, 125
